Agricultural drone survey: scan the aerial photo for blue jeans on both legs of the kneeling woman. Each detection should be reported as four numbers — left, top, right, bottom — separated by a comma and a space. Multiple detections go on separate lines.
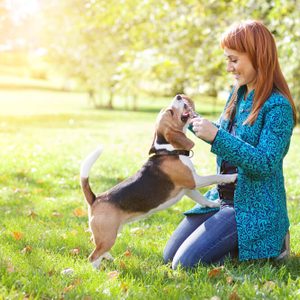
164, 206, 238, 269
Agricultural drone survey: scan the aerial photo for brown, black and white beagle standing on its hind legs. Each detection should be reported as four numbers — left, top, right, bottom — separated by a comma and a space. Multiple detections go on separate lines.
80, 95, 236, 268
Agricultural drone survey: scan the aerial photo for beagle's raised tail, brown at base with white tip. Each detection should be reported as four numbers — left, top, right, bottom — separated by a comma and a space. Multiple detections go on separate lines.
80, 146, 102, 205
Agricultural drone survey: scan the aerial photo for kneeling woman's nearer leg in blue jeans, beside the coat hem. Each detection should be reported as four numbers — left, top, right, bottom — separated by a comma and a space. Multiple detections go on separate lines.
172, 207, 238, 268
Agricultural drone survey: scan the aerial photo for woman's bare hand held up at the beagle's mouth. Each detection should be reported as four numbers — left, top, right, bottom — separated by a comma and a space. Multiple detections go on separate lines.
191, 117, 218, 143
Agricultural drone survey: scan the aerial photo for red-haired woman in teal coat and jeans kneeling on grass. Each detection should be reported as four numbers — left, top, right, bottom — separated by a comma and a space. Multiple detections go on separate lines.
164, 21, 296, 268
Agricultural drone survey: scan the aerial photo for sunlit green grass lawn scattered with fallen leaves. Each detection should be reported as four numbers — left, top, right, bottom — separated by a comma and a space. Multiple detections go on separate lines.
0, 91, 300, 299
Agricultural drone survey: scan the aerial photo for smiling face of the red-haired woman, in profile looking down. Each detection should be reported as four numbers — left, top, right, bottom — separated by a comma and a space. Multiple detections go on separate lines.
224, 48, 257, 92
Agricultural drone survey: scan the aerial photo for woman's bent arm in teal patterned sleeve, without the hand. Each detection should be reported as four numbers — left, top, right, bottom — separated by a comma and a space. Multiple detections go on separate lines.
211, 103, 294, 176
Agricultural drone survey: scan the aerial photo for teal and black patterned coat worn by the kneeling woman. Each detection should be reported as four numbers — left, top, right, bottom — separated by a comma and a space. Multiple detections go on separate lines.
185, 87, 294, 260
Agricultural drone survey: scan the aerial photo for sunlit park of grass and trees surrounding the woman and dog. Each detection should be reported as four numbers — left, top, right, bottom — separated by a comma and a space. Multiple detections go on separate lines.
0, 0, 300, 300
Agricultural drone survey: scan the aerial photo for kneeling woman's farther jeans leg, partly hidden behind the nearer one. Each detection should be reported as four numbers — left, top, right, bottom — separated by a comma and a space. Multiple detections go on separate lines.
163, 211, 217, 263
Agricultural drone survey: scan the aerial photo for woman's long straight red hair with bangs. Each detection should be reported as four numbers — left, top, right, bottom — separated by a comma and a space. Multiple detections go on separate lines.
221, 21, 297, 125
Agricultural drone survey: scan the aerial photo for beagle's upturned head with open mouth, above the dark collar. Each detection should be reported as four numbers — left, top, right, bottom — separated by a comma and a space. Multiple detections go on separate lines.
149, 94, 195, 154
